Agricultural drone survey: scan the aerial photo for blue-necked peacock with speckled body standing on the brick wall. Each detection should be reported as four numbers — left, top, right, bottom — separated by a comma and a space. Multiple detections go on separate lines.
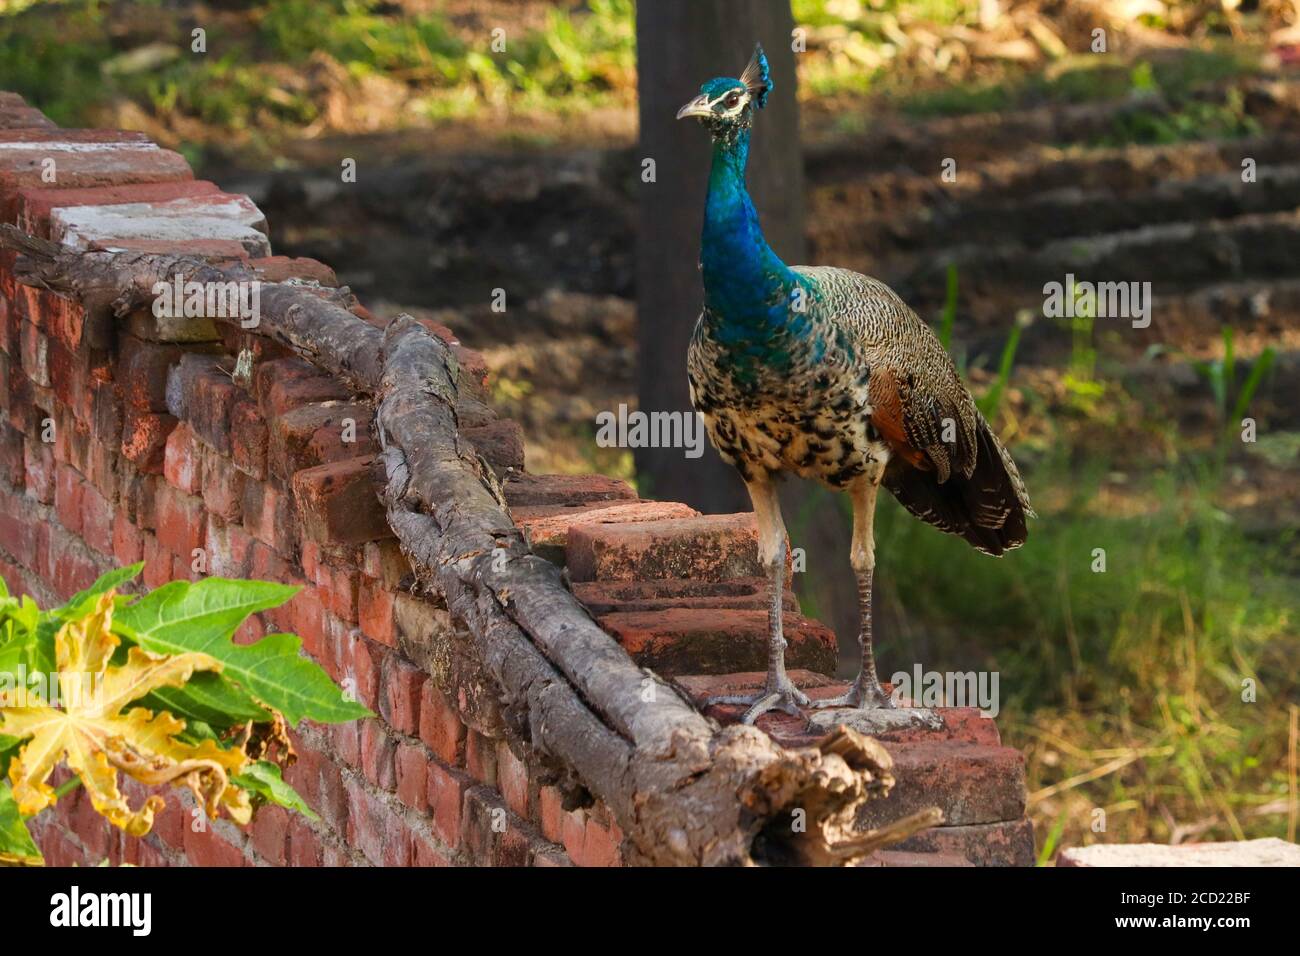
677, 46, 1034, 723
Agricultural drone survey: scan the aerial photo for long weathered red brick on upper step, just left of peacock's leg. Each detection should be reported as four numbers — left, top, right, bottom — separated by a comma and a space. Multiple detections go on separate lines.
568, 514, 763, 581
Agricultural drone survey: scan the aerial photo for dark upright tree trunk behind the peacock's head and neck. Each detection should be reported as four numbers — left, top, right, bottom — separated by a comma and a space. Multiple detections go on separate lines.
636, 0, 803, 512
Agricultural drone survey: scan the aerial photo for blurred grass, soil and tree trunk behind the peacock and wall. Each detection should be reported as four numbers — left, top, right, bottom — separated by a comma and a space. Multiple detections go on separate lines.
0, 0, 1300, 860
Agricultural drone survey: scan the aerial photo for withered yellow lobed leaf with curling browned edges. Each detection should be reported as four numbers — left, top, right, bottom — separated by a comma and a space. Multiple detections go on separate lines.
0, 592, 252, 836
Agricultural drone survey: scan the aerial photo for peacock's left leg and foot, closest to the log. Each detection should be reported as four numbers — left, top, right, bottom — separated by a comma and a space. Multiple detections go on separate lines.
705, 477, 809, 723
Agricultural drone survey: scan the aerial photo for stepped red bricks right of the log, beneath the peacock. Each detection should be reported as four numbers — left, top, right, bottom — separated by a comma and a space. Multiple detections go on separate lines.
506, 476, 1034, 866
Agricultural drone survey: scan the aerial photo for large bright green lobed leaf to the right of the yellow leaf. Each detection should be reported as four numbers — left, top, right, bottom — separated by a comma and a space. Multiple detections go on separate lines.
113, 578, 371, 724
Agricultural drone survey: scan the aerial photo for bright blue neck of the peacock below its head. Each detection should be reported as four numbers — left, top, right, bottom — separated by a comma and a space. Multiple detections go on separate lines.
699, 129, 798, 325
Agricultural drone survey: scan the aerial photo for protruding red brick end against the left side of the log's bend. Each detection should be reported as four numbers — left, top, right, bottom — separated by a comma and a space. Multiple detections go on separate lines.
294, 457, 393, 545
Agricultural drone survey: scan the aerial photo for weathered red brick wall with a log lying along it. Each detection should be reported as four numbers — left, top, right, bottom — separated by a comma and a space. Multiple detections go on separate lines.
0, 94, 1034, 866
